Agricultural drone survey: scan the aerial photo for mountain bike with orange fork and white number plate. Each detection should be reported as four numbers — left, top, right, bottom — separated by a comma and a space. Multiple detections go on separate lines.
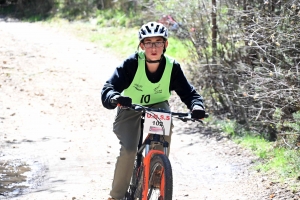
114, 102, 208, 200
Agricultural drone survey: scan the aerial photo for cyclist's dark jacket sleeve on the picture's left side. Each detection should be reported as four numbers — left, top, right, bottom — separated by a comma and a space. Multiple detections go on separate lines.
101, 54, 138, 109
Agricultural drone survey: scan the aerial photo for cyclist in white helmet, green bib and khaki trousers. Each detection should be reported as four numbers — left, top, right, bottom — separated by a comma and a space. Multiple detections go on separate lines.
101, 22, 205, 200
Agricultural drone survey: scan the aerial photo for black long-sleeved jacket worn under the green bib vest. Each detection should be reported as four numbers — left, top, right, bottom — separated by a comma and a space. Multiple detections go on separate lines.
101, 53, 204, 109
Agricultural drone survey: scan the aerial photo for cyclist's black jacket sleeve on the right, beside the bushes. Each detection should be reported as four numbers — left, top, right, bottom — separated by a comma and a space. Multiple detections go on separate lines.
170, 61, 205, 110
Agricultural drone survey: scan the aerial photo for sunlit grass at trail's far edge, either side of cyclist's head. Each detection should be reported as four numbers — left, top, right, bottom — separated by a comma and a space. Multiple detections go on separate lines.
42, 18, 188, 62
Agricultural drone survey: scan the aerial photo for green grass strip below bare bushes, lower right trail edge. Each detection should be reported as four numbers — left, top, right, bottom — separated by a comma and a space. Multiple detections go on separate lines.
212, 120, 300, 190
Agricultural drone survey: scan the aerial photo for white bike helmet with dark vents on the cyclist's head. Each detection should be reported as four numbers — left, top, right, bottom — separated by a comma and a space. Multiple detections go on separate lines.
139, 22, 168, 41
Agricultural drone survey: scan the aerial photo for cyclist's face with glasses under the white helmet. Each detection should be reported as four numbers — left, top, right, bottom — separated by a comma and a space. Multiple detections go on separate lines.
140, 37, 168, 60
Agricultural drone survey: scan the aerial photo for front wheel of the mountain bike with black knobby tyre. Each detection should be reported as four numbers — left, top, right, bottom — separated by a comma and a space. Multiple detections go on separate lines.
147, 154, 173, 200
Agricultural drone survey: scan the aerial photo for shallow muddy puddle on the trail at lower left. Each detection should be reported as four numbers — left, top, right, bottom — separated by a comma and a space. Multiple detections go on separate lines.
0, 160, 45, 199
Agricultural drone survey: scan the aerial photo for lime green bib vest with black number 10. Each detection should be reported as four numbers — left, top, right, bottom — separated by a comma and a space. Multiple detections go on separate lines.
122, 52, 174, 105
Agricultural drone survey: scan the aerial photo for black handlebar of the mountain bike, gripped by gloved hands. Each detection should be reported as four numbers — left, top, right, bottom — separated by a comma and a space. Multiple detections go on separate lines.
110, 99, 209, 123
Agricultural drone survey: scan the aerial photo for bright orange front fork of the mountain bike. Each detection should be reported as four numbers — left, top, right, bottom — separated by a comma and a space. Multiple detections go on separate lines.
142, 150, 165, 200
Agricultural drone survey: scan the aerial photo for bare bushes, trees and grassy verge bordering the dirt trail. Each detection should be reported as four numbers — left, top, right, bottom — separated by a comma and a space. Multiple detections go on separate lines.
0, 0, 300, 192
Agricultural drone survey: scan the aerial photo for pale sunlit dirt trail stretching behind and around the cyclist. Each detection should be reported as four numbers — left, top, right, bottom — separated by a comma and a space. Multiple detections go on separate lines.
0, 21, 299, 200
